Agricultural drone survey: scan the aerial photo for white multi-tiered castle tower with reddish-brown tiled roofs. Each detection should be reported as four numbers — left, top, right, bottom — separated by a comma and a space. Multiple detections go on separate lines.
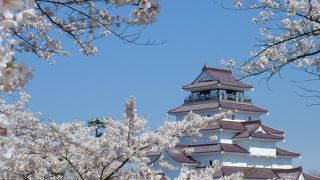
149, 66, 320, 180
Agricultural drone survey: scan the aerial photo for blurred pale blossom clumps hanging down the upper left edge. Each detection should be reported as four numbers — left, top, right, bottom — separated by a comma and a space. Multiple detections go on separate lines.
0, 0, 35, 92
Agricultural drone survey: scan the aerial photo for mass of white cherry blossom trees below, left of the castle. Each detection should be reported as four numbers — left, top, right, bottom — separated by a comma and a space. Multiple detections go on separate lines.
0, 93, 241, 179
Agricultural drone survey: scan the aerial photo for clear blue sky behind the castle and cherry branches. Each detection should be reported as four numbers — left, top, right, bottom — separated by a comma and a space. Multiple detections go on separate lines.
19, 0, 320, 172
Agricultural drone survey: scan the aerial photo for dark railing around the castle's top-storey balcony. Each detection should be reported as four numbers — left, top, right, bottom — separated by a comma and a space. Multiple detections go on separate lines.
184, 94, 251, 103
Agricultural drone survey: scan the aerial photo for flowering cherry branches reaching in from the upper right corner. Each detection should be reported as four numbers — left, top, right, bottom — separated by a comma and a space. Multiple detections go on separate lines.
234, 0, 320, 77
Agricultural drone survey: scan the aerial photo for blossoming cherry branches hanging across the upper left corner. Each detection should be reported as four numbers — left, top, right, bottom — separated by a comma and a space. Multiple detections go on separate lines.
0, 0, 159, 92
